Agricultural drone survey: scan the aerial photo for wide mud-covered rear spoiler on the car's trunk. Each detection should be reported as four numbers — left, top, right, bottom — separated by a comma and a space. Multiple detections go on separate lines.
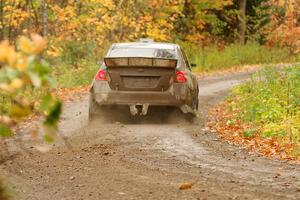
104, 57, 177, 69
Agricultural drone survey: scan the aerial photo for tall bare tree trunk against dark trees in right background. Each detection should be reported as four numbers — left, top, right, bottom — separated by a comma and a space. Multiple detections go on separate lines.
239, 0, 247, 44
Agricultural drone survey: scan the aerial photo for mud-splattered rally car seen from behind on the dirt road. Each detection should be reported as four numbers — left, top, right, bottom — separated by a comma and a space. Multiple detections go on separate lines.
89, 42, 198, 117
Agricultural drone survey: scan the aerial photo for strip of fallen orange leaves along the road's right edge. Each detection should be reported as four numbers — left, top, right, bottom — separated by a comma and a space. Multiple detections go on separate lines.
206, 102, 297, 160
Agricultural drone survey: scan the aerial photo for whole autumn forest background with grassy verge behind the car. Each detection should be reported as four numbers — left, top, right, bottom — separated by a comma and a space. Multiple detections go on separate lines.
0, 0, 299, 83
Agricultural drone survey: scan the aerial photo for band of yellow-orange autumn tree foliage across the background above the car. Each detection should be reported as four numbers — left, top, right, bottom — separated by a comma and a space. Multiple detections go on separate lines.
0, 0, 299, 56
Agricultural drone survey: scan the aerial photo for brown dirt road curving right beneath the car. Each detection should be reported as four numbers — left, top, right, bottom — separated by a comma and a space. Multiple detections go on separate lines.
0, 73, 300, 200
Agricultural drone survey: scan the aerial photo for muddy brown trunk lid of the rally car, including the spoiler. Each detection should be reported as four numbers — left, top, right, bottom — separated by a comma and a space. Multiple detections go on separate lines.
104, 57, 177, 91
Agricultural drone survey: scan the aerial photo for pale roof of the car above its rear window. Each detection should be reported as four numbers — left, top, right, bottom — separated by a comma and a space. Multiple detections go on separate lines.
112, 42, 177, 50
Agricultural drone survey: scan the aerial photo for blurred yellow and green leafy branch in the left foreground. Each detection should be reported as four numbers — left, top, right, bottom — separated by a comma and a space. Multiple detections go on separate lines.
0, 34, 61, 142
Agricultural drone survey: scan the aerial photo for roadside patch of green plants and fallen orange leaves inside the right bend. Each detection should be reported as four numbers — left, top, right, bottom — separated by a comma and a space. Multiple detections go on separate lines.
207, 66, 300, 160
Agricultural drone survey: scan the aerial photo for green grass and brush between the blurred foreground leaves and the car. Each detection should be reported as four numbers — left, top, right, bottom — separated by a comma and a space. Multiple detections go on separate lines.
48, 41, 107, 88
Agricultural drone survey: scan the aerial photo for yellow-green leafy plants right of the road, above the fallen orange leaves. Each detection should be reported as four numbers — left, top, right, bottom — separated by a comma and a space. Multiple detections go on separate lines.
232, 66, 300, 152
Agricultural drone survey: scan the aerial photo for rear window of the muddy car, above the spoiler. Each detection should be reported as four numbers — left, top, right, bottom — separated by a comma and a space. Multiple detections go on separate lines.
109, 48, 176, 59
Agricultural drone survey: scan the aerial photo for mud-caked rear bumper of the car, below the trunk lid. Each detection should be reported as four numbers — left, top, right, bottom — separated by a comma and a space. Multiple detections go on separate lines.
91, 82, 186, 107
